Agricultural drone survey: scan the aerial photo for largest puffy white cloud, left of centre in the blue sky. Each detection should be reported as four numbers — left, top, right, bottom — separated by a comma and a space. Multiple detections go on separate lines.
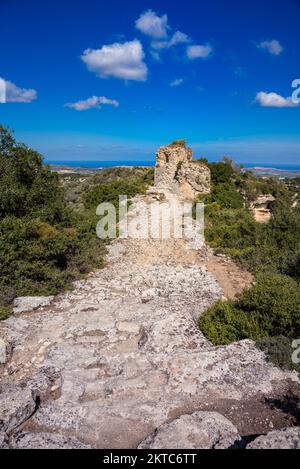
81, 39, 148, 81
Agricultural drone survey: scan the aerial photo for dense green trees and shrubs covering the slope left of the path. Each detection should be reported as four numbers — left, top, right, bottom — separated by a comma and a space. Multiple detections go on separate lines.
0, 126, 151, 319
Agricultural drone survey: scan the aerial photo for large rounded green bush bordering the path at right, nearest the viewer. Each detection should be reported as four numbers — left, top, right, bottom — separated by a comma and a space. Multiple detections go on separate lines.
199, 274, 300, 345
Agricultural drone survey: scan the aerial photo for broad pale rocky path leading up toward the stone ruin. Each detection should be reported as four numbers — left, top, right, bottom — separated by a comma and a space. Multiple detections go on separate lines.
0, 196, 298, 448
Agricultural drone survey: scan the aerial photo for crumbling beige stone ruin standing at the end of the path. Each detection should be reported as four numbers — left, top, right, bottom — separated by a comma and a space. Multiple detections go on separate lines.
149, 145, 211, 200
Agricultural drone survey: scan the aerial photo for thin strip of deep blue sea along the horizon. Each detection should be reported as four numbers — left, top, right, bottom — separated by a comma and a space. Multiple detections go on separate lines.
46, 160, 300, 171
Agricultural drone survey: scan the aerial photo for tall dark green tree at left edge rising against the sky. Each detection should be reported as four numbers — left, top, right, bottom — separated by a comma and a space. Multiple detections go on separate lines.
0, 126, 66, 223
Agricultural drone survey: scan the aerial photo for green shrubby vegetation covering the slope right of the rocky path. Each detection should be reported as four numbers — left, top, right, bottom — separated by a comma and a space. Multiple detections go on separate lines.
199, 159, 300, 368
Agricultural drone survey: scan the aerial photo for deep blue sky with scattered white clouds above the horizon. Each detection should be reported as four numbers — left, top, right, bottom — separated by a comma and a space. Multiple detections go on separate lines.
0, 0, 300, 165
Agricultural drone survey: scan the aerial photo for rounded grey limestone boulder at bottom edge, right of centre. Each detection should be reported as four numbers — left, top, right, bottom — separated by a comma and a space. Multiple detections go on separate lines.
139, 412, 241, 449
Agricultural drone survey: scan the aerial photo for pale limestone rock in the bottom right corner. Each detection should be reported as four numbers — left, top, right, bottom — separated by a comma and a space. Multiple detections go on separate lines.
247, 427, 300, 449
